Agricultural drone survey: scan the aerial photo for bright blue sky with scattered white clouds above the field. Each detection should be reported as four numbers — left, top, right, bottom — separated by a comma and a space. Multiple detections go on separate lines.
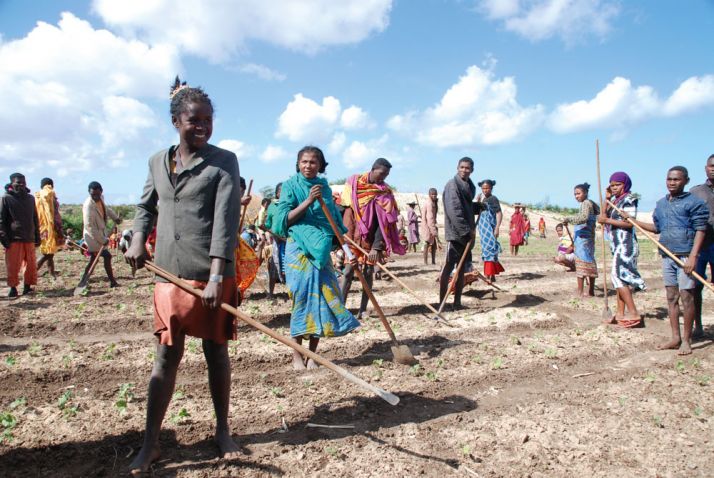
0, 0, 714, 209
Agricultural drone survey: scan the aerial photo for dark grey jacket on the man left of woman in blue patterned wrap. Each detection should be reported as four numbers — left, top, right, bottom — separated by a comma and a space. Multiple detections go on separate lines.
442, 175, 476, 244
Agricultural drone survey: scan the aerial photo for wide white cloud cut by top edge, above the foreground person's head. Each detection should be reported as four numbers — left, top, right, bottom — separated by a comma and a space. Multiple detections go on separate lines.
93, 0, 392, 61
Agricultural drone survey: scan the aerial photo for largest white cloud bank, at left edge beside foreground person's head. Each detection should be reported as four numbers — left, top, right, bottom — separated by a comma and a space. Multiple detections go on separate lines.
0, 13, 180, 181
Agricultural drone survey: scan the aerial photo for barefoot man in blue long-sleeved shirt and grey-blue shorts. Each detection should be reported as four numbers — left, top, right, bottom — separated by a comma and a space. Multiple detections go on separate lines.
635, 166, 709, 355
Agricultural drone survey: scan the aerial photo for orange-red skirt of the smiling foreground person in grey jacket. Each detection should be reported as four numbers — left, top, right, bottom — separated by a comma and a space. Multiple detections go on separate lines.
154, 277, 238, 345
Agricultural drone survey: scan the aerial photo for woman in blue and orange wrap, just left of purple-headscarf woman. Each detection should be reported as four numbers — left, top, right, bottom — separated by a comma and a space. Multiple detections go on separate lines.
563, 183, 600, 297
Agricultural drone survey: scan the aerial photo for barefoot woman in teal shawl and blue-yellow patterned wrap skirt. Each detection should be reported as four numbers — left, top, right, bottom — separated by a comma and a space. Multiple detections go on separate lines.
273, 146, 359, 370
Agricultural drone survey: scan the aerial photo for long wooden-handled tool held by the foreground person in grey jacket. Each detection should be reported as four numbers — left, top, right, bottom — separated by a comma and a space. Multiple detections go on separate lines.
146, 261, 399, 405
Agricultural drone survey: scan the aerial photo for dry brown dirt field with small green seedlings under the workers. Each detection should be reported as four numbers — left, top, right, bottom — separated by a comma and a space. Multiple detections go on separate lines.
0, 230, 714, 477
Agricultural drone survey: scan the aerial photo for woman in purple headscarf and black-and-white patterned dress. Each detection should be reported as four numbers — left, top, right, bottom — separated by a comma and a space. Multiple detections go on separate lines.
597, 172, 645, 327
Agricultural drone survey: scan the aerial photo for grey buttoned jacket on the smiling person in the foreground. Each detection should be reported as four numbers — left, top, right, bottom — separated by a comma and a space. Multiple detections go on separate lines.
134, 144, 240, 281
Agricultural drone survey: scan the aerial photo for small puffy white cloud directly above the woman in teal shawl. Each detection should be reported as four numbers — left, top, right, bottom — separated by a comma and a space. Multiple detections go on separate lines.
275, 93, 374, 144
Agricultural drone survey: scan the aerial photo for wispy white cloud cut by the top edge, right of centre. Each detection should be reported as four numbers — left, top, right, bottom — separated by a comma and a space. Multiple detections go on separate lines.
479, 0, 620, 44
